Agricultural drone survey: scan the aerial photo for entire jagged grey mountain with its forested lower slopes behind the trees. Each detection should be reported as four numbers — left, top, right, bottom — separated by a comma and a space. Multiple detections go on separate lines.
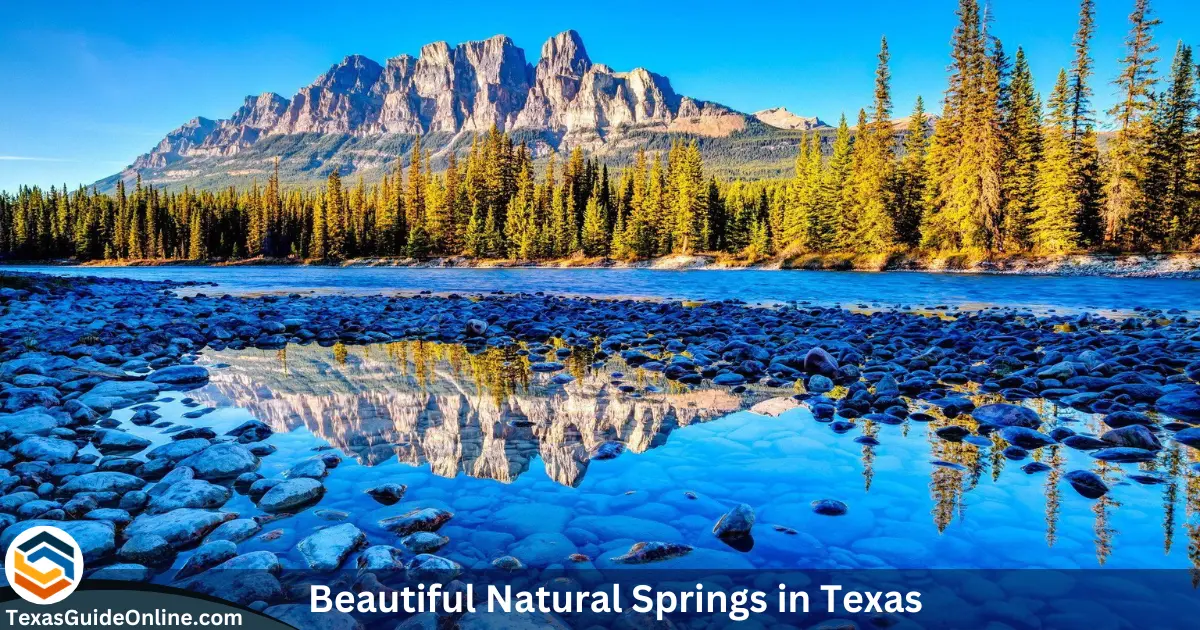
97, 30, 824, 188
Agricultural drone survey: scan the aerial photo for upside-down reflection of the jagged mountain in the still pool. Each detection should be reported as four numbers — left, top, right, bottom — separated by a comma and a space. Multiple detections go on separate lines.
190, 343, 757, 486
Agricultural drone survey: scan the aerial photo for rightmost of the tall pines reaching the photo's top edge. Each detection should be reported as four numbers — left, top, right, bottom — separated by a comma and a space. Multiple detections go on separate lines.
1104, 0, 1159, 248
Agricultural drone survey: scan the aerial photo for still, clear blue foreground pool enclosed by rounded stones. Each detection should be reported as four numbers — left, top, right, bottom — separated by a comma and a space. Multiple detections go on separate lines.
114, 342, 1200, 569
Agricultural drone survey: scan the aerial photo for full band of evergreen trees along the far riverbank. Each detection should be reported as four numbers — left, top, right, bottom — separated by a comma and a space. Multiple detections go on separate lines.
0, 0, 1200, 260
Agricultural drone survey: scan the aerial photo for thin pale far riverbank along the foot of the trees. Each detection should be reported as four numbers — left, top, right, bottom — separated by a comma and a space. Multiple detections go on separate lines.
6, 252, 1200, 278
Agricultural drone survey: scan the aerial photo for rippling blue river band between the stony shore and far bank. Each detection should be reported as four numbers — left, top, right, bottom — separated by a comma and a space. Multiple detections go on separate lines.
4, 266, 1200, 312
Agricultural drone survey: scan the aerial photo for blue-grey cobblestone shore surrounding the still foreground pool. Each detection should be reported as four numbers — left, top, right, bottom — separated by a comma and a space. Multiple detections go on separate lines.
0, 274, 1200, 626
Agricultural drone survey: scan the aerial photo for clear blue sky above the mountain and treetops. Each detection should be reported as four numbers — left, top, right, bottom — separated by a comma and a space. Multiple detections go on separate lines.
0, 0, 1200, 191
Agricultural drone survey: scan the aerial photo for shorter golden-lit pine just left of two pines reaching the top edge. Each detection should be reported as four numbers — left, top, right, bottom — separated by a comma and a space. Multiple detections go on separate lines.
1028, 71, 1080, 253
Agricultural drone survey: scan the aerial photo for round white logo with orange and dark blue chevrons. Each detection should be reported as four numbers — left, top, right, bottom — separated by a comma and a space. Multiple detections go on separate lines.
4, 527, 83, 604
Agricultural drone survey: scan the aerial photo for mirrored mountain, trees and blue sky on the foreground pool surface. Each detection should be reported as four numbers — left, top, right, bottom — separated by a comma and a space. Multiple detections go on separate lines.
193, 341, 1200, 566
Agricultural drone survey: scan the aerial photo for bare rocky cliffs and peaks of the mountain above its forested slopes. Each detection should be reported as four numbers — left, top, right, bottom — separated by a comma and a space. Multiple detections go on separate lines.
105, 30, 748, 190
